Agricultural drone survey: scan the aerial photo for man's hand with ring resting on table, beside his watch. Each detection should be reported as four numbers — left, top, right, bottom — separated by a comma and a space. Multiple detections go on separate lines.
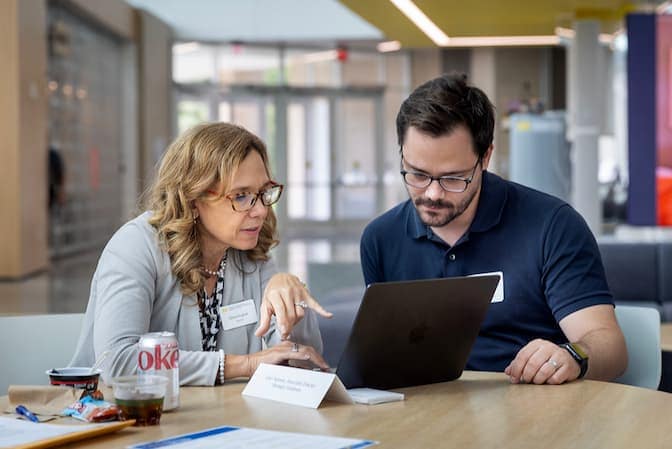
504, 339, 581, 385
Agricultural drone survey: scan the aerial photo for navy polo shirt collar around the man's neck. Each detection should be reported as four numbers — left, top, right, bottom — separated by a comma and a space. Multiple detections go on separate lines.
406, 170, 507, 240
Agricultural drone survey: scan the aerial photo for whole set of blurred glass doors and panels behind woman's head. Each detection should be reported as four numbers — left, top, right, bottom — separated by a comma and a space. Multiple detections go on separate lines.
178, 86, 389, 228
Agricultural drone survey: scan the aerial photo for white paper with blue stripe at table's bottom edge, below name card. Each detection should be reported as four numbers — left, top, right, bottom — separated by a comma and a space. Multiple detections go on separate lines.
127, 426, 378, 449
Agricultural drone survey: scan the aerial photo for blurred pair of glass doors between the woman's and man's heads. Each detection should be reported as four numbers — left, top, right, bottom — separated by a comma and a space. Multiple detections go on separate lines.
278, 89, 384, 229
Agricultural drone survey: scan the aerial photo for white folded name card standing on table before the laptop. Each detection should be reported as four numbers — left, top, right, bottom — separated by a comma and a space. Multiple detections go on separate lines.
243, 363, 353, 408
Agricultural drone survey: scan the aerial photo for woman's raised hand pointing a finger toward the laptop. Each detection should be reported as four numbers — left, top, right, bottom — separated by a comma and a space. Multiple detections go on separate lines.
254, 273, 333, 340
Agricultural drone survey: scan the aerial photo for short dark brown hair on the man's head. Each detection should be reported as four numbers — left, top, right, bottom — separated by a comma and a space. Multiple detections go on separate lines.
397, 74, 495, 158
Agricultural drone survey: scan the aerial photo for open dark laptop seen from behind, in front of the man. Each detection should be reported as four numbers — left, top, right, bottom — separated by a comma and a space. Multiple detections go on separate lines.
336, 275, 499, 390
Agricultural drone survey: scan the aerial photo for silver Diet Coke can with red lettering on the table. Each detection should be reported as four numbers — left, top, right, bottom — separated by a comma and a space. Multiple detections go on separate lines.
138, 332, 180, 411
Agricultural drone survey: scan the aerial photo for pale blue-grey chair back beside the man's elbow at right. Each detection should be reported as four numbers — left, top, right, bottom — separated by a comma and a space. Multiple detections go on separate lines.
614, 305, 662, 390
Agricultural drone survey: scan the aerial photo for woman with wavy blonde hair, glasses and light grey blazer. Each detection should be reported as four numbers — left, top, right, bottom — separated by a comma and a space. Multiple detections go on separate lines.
71, 123, 331, 385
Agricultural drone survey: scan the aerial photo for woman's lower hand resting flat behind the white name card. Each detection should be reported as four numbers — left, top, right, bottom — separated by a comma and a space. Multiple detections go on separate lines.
246, 340, 329, 377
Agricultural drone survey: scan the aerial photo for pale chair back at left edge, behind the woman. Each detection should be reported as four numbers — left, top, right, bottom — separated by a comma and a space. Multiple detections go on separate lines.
0, 313, 84, 395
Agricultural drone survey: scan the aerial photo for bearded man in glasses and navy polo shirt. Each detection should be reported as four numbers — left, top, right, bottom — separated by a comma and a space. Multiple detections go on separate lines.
360, 75, 627, 384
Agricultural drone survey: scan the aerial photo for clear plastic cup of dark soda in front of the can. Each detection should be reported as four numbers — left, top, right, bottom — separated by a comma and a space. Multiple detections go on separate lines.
112, 374, 168, 426
